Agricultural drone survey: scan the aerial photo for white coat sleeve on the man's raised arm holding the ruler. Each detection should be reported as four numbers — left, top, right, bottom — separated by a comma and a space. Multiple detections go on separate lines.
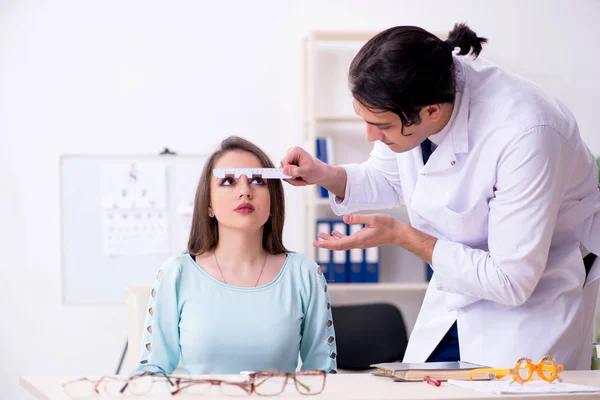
329, 141, 404, 215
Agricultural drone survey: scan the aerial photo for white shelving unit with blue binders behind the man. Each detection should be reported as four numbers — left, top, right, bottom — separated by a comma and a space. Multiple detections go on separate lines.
303, 32, 427, 288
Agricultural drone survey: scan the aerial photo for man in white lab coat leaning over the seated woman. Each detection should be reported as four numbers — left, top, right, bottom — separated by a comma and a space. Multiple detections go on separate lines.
281, 24, 600, 369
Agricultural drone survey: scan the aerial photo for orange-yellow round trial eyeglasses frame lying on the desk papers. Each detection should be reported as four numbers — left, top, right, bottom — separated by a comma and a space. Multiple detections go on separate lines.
469, 356, 565, 384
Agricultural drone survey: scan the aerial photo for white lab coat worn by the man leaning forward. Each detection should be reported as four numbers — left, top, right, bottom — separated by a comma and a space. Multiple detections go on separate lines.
330, 57, 600, 369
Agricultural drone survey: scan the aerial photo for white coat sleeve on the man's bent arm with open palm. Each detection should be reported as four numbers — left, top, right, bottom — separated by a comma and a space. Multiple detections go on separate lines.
432, 126, 572, 306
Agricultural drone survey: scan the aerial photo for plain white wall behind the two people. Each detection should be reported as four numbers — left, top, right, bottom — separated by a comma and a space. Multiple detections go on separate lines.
0, 0, 600, 399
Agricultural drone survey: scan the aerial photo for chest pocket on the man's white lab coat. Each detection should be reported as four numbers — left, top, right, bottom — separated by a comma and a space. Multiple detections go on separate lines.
443, 199, 489, 247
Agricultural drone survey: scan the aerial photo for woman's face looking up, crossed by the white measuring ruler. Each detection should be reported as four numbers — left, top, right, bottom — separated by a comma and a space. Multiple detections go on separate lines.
209, 151, 271, 232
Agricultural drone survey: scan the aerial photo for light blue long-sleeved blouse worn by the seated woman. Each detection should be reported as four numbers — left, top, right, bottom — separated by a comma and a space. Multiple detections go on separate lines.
137, 253, 337, 374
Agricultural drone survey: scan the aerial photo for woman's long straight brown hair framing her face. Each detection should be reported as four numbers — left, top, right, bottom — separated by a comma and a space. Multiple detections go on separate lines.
187, 136, 288, 256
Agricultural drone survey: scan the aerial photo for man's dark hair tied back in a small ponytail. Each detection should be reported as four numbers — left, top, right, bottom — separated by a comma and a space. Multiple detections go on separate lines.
348, 23, 487, 128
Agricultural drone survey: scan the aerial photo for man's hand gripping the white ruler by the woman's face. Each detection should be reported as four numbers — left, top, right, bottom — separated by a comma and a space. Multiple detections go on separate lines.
280, 147, 327, 186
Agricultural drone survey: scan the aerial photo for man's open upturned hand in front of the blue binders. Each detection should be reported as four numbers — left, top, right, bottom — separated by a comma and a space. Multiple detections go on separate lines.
313, 214, 406, 250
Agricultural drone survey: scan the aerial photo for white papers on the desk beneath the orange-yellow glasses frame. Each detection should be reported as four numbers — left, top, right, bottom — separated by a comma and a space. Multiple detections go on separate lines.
448, 380, 600, 394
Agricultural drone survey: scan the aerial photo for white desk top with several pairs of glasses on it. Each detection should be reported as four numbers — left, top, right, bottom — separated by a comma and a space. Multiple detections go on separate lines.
21, 371, 600, 400
